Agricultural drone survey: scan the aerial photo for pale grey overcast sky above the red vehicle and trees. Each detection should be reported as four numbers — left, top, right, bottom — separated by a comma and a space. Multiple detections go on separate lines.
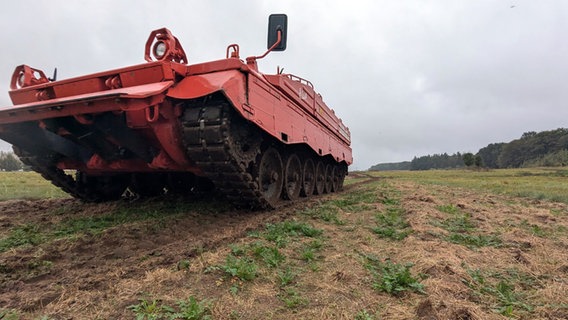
0, 0, 568, 169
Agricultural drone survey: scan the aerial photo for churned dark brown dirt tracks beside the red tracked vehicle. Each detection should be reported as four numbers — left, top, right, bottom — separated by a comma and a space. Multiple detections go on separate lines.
0, 190, 346, 312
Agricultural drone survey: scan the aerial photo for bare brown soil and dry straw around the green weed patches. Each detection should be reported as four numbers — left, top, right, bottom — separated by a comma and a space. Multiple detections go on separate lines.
0, 175, 568, 319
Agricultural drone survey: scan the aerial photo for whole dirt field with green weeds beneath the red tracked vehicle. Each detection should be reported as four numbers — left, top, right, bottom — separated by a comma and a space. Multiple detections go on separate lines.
0, 174, 568, 319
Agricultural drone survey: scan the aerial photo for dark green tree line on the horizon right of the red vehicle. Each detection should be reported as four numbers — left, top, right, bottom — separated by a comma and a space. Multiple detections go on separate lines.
369, 128, 568, 170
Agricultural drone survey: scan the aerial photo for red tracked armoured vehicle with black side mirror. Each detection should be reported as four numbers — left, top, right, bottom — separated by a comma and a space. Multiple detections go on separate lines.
0, 15, 353, 208
